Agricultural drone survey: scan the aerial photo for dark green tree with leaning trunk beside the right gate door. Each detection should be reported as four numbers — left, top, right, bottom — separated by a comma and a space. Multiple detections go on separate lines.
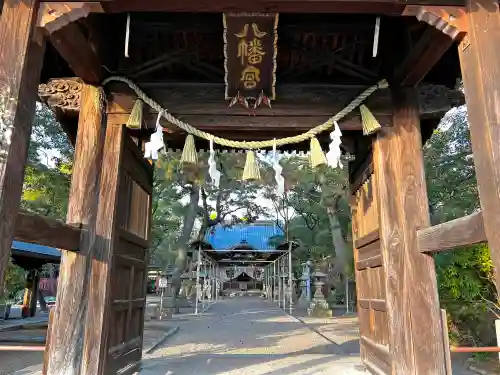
265, 156, 352, 290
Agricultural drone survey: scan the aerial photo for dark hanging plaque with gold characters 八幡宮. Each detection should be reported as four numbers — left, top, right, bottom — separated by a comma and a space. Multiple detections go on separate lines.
223, 13, 278, 109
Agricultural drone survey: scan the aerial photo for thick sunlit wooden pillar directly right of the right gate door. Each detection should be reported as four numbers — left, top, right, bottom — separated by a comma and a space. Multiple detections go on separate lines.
373, 88, 446, 375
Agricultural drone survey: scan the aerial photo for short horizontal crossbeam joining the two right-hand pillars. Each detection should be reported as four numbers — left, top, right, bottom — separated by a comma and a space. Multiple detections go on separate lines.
418, 212, 487, 253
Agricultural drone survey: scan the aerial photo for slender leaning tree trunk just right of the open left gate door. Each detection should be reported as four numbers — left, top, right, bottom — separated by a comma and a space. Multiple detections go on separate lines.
172, 184, 200, 314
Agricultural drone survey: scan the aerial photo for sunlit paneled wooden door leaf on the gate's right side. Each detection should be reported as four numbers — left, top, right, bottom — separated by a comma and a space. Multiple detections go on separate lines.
351, 176, 391, 374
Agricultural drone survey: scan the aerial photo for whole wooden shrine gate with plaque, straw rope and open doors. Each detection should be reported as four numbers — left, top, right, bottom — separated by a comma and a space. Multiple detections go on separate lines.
0, 0, 500, 375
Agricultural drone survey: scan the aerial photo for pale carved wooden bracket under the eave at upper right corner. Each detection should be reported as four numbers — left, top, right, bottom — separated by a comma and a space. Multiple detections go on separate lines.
403, 5, 467, 41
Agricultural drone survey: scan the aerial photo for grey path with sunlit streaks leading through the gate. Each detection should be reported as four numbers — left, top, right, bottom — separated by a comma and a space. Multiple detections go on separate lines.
140, 297, 366, 375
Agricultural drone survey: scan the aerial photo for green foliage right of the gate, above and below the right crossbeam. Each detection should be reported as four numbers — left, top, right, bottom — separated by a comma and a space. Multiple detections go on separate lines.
424, 107, 497, 345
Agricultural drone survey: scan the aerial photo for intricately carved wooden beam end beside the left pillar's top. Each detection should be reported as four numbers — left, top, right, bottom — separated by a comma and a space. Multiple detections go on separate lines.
38, 78, 83, 112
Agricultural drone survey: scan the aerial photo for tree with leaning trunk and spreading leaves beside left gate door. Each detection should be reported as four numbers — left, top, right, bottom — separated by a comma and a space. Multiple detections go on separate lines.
153, 153, 263, 310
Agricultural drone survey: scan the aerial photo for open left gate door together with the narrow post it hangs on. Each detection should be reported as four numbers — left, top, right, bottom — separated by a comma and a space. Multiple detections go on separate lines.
82, 121, 153, 375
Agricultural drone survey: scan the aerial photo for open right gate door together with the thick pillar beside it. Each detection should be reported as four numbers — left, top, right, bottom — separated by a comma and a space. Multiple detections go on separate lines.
350, 89, 449, 375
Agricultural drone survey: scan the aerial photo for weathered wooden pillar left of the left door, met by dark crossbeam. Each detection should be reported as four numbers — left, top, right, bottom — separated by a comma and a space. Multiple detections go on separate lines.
45, 85, 106, 375
